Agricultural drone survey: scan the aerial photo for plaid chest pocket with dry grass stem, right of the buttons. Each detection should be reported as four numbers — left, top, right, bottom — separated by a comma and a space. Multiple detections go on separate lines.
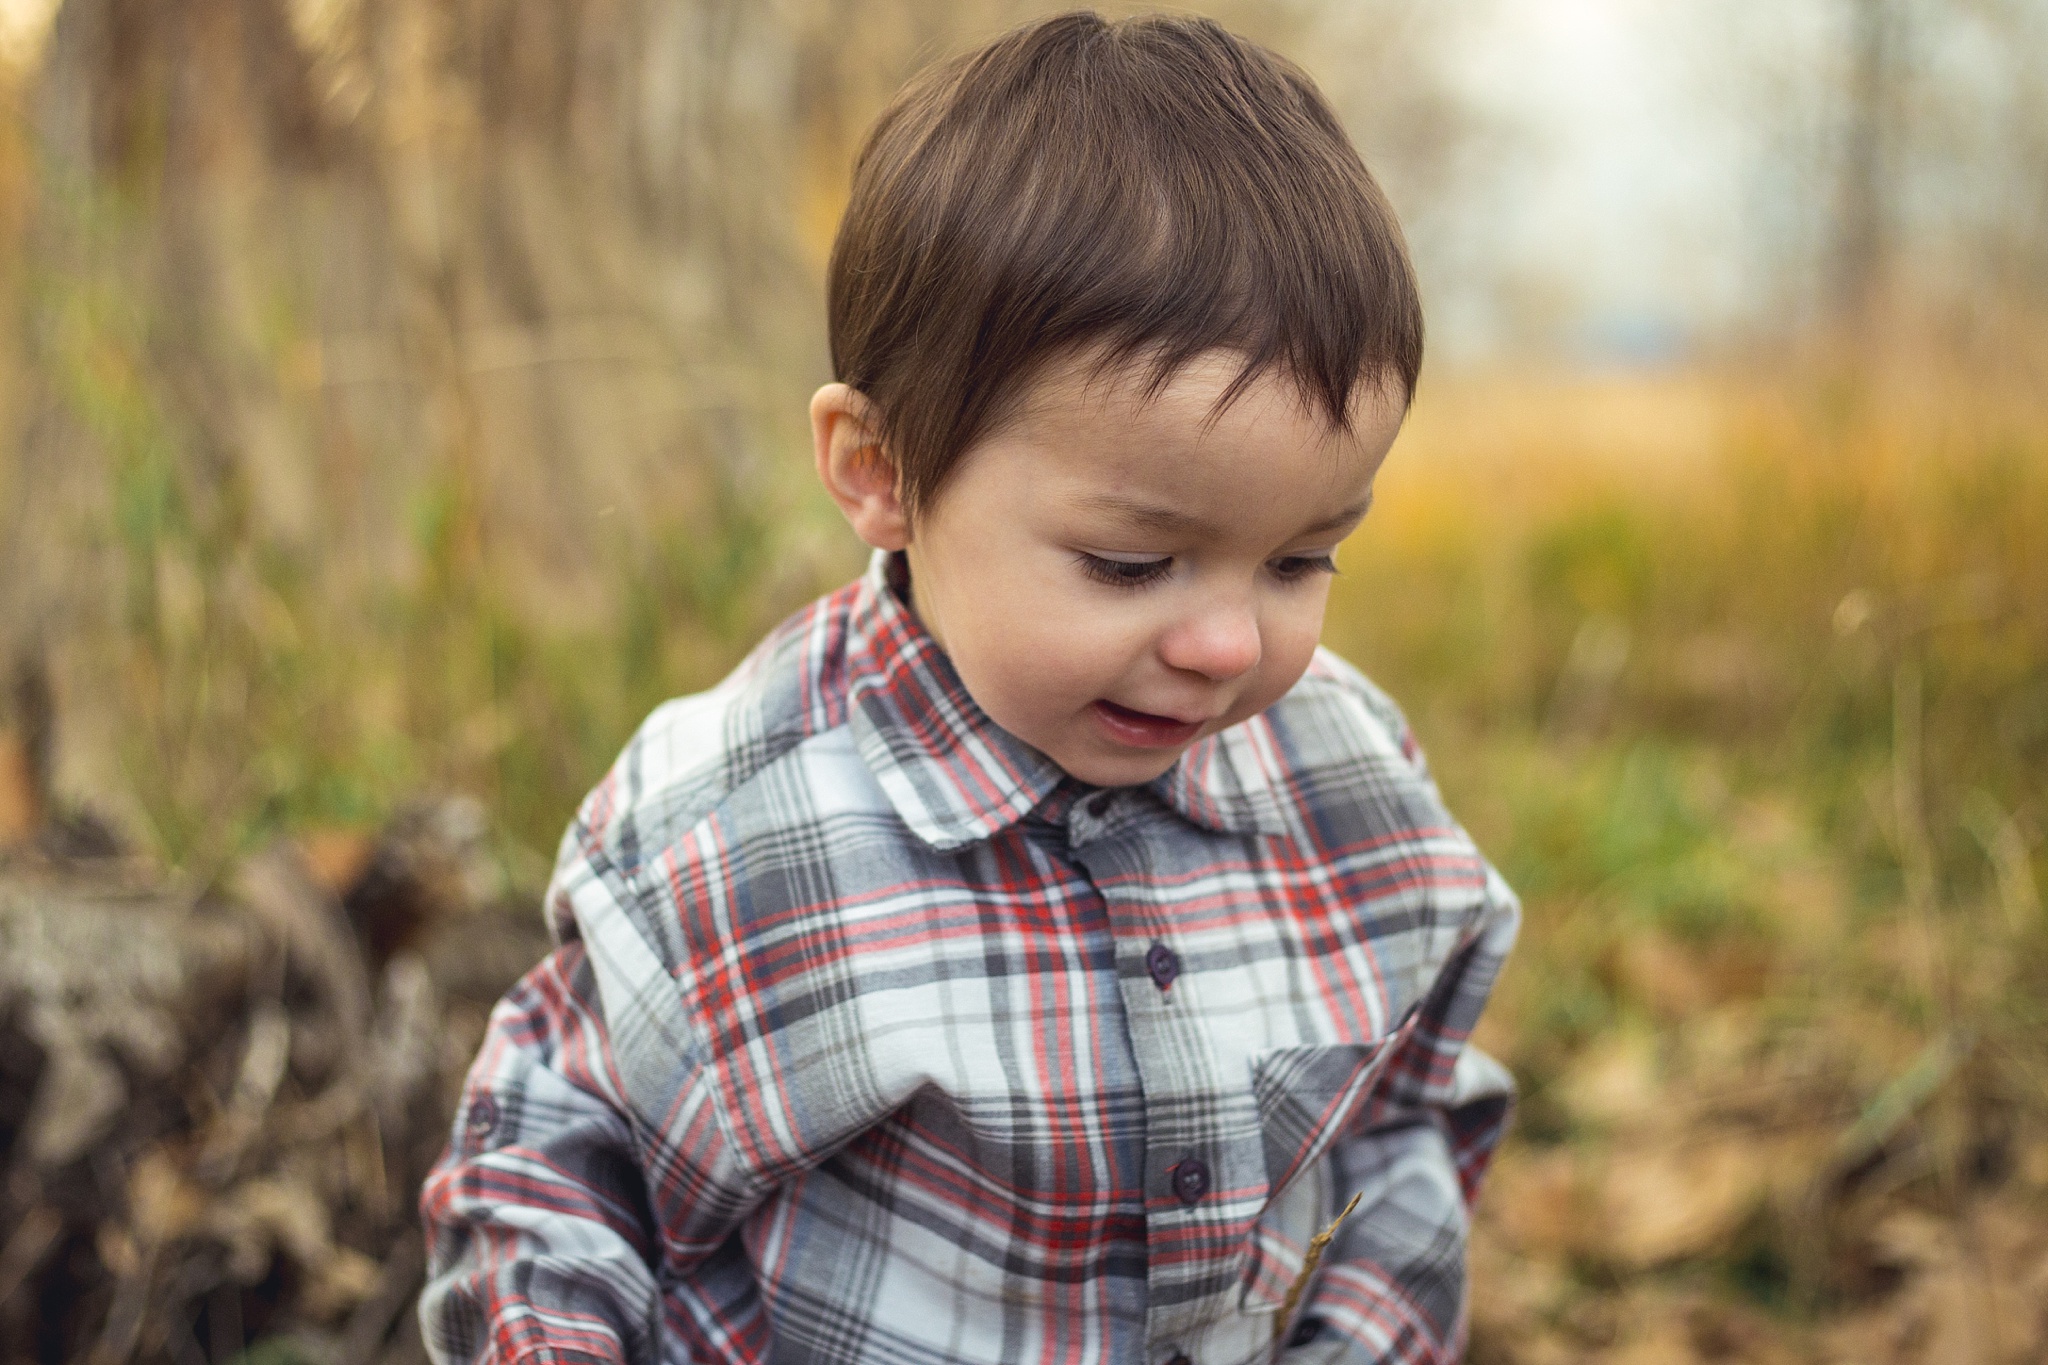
1241, 1015, 1417, 1314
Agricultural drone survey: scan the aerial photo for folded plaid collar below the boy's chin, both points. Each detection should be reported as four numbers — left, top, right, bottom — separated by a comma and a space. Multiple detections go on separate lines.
846, 551, 1288, 849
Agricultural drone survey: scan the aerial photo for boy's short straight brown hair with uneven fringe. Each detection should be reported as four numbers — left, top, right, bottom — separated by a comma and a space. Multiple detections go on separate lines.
827, 12, 1421, 514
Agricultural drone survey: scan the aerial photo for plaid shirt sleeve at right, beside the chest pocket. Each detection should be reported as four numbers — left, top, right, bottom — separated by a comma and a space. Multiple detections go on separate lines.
1280, 874, 1520, 1365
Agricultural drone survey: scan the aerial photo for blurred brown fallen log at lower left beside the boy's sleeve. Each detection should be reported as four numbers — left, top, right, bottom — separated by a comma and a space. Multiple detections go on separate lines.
0, 802, 547, 1365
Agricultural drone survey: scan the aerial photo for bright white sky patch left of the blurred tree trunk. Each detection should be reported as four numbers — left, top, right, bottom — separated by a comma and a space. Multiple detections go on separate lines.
1432, 0, 1761, 360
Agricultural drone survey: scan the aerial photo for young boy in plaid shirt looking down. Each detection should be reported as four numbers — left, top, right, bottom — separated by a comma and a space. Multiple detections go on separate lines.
420, 14, 1516, 1365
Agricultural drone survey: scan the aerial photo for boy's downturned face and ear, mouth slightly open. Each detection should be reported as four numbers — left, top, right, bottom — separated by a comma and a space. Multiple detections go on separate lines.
813, 352, 1403, 786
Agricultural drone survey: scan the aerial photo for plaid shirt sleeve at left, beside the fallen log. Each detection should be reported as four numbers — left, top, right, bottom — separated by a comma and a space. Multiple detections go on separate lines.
420, 941, 768, 1365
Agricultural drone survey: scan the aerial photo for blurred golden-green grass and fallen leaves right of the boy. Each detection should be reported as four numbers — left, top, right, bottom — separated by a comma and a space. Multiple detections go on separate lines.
1329, 375, 2048, 1363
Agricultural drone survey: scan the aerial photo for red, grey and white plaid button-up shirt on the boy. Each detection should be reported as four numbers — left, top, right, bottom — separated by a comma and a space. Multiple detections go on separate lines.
420, 557, 1518, 1365
